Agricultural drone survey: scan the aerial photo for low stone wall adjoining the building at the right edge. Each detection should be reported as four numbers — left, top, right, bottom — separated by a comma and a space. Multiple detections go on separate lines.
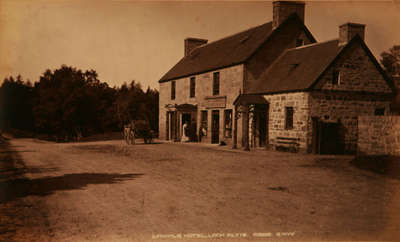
357, 116, 400, 155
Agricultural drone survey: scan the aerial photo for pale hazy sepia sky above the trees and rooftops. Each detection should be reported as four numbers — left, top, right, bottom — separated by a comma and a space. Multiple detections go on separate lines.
0, 0, 400, 89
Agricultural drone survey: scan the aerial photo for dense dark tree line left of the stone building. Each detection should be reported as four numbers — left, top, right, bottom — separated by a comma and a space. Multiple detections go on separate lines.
0, 65, 158, 139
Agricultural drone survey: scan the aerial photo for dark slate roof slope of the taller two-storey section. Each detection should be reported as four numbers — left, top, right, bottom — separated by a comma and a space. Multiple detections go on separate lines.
159, 22, 272, 82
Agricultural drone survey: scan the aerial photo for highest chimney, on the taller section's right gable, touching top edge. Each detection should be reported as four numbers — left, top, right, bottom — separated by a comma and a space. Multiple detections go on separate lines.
272, 1, 305, 29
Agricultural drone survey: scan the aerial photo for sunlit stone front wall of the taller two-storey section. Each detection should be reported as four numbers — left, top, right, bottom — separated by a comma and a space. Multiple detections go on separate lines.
159, 65, 243, 143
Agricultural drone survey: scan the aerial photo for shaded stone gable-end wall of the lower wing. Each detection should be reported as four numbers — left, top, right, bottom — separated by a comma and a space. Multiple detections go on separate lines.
309, 40, 392, 152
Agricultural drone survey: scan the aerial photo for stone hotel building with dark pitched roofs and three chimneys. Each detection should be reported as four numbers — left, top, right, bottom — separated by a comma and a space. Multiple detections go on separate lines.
159, 1, 394, 153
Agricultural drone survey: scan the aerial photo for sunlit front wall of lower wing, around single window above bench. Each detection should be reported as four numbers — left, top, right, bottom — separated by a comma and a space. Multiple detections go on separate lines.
264, 92, 310, 151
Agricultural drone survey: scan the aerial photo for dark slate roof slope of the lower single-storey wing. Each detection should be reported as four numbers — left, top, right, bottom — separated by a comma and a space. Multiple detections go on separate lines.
247, 40, 345, 93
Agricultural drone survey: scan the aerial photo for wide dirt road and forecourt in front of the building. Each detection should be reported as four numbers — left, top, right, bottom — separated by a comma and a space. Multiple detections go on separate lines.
0, 139, 400, 241
